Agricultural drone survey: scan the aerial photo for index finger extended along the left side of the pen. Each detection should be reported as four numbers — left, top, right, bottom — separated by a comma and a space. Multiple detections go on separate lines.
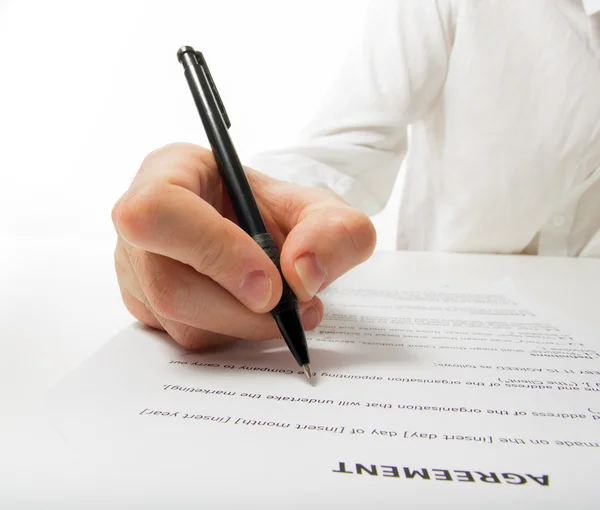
113, 144, 282, 312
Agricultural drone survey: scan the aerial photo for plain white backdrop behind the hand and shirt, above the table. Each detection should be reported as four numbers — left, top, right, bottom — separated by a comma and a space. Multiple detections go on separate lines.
0, 0, 395, 249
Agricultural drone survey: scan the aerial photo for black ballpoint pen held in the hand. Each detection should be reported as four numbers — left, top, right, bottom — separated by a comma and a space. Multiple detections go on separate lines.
177, 46, 312, 379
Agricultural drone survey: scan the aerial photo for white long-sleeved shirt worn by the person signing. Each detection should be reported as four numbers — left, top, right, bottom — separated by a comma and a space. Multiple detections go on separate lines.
251, 0, 600, 257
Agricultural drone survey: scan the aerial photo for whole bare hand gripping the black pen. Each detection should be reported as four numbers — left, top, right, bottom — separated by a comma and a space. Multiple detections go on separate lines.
112, 144, 375, 349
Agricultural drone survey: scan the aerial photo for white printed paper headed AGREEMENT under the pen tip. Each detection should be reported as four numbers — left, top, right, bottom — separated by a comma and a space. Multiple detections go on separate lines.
12, 287, 600, 509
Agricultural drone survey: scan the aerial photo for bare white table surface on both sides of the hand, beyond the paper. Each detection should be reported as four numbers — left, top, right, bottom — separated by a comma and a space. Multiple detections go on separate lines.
0, 237, 600, 419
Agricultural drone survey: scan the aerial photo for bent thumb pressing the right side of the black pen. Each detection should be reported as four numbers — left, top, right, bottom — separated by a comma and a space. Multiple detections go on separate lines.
281, 200, 377, 301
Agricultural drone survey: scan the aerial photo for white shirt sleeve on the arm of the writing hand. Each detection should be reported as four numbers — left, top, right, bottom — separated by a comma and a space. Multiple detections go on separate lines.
250, 0, 453, 215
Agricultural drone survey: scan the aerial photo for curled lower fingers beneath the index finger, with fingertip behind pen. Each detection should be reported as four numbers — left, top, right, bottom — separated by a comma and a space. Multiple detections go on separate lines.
113, 241, 323, 349
